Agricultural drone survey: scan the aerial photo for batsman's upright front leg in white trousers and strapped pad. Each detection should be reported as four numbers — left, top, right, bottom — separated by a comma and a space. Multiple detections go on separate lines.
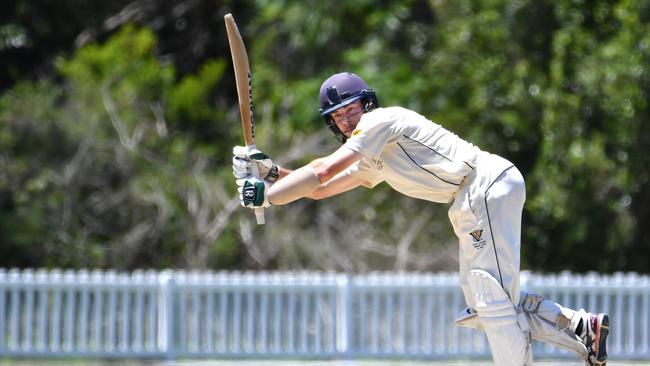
450, 167, 532, 365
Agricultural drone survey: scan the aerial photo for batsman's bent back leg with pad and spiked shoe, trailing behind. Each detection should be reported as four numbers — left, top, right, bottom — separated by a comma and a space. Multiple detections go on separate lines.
474, 163, 609, 365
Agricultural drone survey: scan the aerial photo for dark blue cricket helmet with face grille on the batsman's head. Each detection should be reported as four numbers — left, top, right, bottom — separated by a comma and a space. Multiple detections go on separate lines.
318, 72, 379, 143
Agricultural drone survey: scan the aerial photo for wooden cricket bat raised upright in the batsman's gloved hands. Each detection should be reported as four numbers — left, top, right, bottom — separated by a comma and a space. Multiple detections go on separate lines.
223, 13, 265, 225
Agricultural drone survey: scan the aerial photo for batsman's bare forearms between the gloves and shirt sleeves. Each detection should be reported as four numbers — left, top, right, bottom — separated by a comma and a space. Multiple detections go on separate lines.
267, 146, 364, 205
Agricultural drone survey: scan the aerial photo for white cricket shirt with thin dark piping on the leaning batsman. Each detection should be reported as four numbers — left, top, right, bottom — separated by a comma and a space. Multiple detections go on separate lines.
343, 107, 482, 203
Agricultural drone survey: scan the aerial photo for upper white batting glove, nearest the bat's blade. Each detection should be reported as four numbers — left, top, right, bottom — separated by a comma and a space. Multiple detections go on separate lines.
232, 146, 279, 183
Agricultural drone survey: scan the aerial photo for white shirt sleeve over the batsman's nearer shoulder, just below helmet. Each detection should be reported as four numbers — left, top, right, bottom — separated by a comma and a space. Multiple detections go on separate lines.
344, 109, 398, 158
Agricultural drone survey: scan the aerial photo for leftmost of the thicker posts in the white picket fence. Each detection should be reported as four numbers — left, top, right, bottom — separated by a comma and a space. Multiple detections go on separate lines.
158, 271, 174, 360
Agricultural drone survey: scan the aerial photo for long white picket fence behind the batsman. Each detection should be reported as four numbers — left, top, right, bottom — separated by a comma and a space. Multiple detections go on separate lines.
0, 269, 650, 360
